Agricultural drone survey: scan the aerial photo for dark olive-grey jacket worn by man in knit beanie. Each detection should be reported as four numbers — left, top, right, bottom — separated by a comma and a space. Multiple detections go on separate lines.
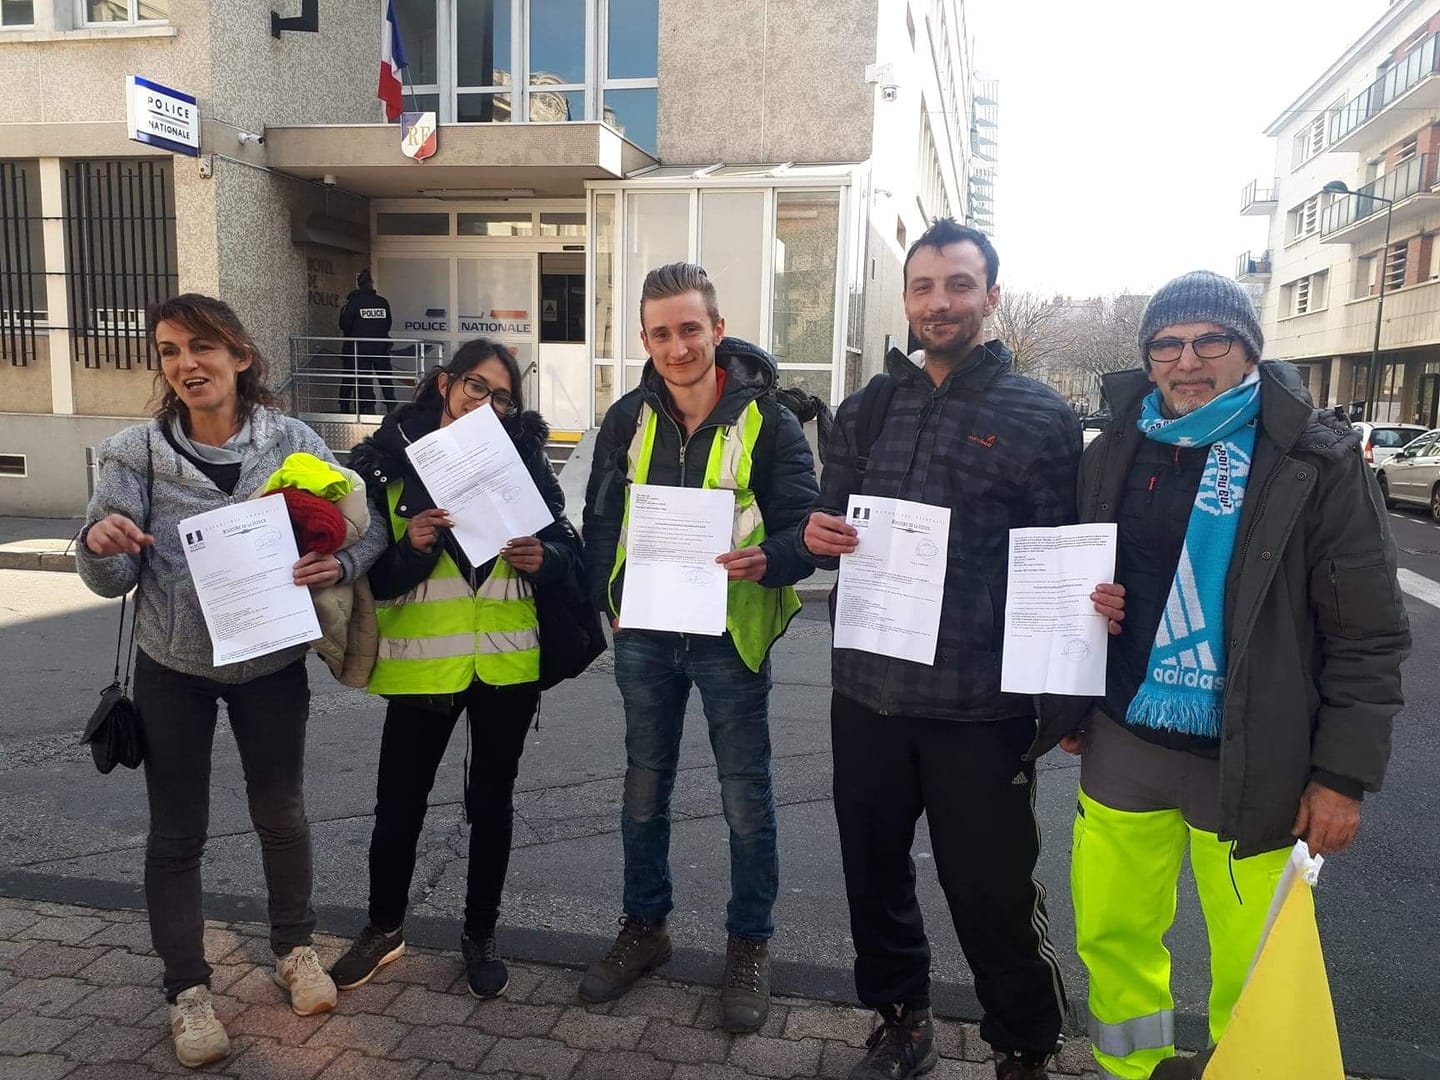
1032, 363, 1410, 858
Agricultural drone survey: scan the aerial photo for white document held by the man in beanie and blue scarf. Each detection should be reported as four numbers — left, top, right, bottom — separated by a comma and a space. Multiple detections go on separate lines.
999, 523, 1116, 697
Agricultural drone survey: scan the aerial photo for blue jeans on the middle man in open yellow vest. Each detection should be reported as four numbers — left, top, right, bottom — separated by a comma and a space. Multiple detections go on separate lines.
615, 631, 780, 939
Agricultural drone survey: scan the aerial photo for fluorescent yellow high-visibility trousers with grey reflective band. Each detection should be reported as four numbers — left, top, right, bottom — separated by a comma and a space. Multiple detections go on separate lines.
1070, 789, 1290, 1080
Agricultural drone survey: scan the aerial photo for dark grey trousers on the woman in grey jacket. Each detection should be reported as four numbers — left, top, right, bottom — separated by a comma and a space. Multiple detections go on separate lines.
135, 652, 315, 1002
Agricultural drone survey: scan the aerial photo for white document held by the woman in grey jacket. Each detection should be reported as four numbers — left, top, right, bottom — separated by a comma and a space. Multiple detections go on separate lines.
179, 494, 320, 667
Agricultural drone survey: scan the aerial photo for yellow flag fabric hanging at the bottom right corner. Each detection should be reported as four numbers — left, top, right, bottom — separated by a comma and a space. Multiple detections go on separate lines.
1205, 852, 1345, 1080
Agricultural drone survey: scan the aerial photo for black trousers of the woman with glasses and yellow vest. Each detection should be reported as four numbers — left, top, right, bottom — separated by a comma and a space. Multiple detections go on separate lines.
370, 681, 540, 937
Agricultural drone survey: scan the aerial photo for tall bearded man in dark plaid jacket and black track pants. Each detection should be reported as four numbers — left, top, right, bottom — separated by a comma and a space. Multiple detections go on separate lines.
801, 219, 1120, 1080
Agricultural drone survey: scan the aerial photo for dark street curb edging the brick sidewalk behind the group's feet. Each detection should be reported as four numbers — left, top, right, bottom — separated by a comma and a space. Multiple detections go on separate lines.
0, 870, 1440, 1080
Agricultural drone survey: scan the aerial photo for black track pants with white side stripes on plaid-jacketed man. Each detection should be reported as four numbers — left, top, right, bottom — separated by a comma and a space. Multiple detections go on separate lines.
831, 694, 1066, 1053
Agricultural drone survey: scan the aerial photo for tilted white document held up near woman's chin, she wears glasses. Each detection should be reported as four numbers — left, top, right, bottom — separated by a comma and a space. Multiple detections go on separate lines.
405, 406, 554, 566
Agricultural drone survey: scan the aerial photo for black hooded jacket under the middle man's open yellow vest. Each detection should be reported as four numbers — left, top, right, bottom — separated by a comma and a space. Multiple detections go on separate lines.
585, 337, 819, 616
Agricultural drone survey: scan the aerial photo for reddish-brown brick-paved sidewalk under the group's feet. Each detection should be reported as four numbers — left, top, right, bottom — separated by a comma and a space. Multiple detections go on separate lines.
0, 897, 1111, 1080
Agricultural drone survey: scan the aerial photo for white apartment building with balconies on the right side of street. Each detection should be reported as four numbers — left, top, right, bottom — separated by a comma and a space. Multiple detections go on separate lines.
1237, 0, 1440, 426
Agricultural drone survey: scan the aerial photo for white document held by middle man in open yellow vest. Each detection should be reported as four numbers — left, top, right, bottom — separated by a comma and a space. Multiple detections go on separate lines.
621, 484, 734, 636
